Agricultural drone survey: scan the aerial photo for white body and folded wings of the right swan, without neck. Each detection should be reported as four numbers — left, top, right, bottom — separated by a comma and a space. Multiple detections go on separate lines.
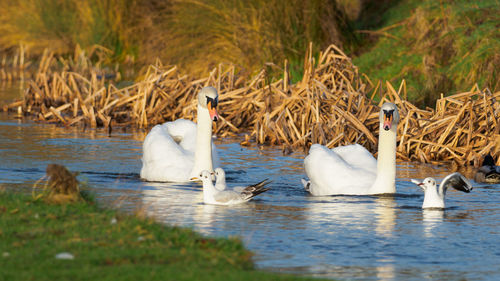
304, 144, 376, 195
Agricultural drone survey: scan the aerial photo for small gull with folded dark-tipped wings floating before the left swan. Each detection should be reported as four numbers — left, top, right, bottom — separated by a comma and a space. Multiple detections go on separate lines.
195, 170, 269, 205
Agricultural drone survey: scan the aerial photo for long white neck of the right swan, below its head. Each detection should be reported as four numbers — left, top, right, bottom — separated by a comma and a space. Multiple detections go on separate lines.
370, 126, 397, 194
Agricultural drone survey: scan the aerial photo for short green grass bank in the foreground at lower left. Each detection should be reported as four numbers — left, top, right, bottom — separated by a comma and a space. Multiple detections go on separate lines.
0, 192, 320, 280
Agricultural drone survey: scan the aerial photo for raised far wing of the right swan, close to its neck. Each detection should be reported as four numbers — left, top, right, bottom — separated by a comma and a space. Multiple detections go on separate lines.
332, 144, 377, 173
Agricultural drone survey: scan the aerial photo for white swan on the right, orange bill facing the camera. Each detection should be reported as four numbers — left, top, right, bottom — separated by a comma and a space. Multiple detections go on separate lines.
302, 102, 399, 196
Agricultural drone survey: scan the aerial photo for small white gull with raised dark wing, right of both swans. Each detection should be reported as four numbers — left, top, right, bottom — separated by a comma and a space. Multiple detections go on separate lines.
411, 172, 472, 209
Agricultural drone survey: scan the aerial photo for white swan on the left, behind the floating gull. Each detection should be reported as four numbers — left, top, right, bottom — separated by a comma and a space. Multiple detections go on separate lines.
141, 87, 219, 182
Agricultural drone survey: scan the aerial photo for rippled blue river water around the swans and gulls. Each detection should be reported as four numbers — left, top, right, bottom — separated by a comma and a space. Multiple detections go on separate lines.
0, 83, 500, 280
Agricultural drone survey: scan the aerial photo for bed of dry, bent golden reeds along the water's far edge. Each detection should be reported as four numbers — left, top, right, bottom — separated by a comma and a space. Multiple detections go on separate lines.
4, 45, 500, 166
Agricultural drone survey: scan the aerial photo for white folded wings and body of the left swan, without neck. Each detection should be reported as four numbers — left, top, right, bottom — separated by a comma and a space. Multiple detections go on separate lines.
141, 120, 196, 182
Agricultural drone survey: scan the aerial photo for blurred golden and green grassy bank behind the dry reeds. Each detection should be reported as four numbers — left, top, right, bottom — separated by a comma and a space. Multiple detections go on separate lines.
0, 0, 494, 103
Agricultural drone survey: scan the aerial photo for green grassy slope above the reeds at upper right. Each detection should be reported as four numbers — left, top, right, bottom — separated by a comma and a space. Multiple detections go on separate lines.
353, 0, 500, 106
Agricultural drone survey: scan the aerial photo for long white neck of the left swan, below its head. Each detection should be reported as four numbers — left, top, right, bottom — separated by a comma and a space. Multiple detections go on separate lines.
191, 105, 214, 177
